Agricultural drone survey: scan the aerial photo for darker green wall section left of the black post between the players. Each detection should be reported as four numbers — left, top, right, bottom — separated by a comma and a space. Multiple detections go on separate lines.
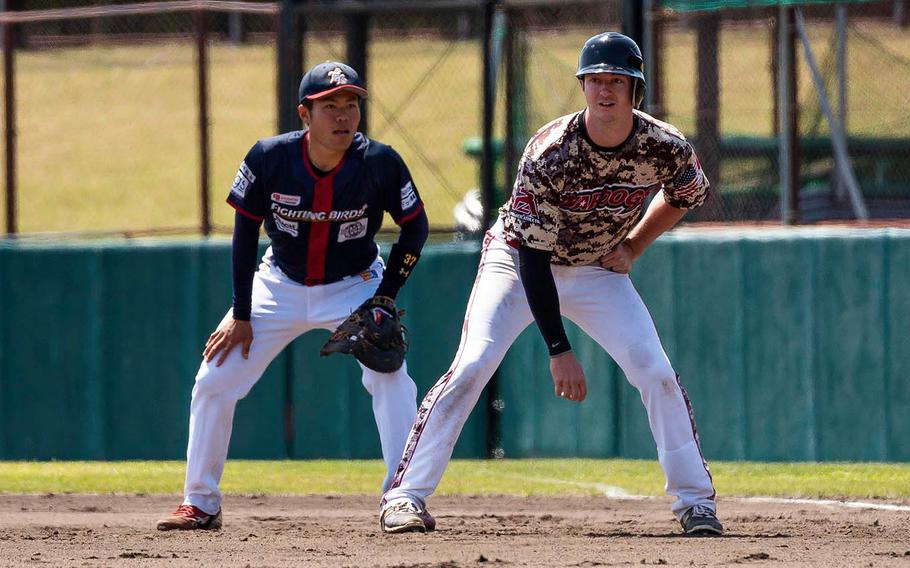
0, 240, 486, 459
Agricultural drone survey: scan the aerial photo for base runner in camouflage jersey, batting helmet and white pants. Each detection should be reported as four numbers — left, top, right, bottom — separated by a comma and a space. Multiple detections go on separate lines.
380, 33, 723, 535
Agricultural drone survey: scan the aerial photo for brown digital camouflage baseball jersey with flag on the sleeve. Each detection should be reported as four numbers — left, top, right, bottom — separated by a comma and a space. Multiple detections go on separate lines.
499, 110, 709, 266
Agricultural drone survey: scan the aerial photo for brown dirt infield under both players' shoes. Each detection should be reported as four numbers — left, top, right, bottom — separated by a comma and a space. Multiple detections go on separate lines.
0, 495, 910, 568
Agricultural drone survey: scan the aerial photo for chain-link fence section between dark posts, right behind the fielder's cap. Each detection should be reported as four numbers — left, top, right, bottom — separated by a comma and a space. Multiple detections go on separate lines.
303, 3, 483, 235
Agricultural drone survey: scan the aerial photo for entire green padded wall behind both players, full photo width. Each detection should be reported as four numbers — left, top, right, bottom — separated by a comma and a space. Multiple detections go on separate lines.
0, 228, 910, 461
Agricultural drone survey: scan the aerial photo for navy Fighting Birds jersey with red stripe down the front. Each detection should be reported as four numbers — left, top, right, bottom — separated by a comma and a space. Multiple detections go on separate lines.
227, 131, 423, 285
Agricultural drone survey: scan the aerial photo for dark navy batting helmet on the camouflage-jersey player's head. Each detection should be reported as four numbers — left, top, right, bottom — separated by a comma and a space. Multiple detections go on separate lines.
575, 32, 645, 108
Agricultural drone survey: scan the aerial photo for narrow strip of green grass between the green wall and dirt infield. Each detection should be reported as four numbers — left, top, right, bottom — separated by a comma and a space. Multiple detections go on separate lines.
0, 459, 910, 501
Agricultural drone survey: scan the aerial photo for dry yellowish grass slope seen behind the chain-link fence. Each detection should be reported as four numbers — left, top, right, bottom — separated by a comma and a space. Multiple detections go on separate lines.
7, 22, 910, 232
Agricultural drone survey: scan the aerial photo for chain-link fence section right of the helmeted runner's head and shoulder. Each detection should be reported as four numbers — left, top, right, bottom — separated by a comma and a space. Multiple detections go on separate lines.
660, 2, 910, 222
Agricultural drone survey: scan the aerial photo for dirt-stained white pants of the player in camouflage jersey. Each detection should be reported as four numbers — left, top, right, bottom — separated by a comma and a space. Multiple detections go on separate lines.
382, 234, 715, 518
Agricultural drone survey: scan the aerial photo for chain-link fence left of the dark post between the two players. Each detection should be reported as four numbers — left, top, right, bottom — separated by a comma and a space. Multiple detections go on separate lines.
0, 1, 492, 233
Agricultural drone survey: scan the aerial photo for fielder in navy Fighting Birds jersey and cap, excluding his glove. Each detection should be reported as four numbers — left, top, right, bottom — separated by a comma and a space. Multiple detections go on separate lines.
158, 62, 428, 530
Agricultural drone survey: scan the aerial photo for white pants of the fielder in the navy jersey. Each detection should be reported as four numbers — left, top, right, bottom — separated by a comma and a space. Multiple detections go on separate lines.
184, 252, 417, 514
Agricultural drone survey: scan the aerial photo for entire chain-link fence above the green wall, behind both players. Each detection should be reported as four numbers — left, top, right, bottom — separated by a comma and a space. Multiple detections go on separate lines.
4, 0, 910, 233
